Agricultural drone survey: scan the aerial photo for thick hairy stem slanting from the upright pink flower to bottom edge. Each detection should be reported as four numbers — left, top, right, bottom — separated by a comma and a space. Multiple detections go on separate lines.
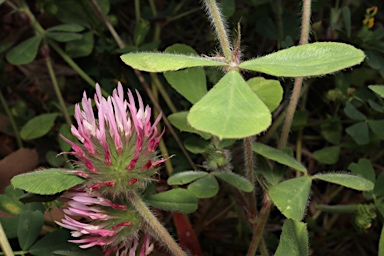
129, 191, 187, 256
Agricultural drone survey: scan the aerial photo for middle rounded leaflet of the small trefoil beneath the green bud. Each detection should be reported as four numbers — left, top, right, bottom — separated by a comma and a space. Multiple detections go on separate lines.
188, 174, 219, 198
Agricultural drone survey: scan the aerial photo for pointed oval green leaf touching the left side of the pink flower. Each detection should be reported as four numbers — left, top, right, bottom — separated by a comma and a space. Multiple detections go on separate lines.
11, 169, 84, 195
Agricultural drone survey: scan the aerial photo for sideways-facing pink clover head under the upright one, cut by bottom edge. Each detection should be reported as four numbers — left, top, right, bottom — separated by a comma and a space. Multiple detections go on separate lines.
56, 188, 153, 256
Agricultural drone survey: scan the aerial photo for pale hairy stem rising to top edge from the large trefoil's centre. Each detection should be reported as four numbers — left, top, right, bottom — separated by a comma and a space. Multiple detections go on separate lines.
204, 0, 232, 61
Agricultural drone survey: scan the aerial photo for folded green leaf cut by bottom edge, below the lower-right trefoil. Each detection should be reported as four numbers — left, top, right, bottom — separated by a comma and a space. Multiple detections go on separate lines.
275, 219, 308, 256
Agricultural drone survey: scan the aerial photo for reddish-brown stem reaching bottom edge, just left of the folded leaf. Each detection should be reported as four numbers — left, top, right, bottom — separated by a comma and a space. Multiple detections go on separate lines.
247, 193, 272, 256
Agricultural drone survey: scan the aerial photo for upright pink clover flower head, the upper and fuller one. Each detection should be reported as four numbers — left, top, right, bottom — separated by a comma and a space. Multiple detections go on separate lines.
62, 83, 166, 197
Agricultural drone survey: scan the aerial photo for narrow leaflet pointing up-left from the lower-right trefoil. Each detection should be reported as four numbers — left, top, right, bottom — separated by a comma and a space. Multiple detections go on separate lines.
252, 142, 307, 173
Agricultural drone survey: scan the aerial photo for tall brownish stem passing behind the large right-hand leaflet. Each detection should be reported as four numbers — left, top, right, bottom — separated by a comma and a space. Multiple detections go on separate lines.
279, 0, 311, 148
